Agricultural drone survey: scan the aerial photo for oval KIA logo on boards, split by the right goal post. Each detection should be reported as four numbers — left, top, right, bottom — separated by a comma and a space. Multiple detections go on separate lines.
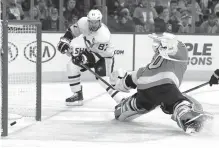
24, 41, 56, 63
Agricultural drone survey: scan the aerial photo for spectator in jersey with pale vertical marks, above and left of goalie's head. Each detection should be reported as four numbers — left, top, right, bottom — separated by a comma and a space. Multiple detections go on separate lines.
133, 0, 155, 32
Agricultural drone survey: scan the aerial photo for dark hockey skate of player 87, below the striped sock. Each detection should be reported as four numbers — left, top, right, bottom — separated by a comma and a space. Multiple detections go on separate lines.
65, 90, 84, 106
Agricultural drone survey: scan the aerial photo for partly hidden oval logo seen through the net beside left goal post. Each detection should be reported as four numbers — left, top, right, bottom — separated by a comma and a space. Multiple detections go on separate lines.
8, 42, 18, 63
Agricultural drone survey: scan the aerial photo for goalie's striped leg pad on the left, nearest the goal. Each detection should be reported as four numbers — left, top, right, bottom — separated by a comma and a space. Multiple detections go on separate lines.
114, 94, 148, 121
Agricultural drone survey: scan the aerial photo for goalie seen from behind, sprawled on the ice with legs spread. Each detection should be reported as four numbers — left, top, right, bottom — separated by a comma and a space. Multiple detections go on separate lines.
111, 33, 212, 133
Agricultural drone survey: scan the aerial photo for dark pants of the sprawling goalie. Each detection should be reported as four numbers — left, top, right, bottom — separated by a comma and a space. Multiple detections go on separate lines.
135, 84, 202, 114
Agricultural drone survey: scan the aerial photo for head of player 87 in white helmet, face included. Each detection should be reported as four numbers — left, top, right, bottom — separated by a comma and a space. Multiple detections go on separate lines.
87, 9, 103, 31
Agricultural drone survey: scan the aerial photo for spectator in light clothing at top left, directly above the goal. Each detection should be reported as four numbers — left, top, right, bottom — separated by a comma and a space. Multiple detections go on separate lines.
7, 0, 24, 20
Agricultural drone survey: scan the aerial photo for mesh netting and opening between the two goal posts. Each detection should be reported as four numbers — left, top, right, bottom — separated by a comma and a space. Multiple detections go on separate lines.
8, 24, 37, 120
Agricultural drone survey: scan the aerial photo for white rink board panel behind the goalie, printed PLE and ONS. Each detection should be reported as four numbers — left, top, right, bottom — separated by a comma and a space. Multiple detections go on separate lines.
135, 35, 219, 71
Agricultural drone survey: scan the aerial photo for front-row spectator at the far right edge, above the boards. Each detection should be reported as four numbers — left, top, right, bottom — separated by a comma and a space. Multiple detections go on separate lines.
200, 14, 219, 34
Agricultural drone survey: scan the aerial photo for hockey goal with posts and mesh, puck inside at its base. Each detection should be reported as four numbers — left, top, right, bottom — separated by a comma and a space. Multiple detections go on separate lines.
0, 21, 41, 136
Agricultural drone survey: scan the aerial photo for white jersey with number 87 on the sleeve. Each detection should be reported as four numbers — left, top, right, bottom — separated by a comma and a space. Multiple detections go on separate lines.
70, 17, 114, 58
